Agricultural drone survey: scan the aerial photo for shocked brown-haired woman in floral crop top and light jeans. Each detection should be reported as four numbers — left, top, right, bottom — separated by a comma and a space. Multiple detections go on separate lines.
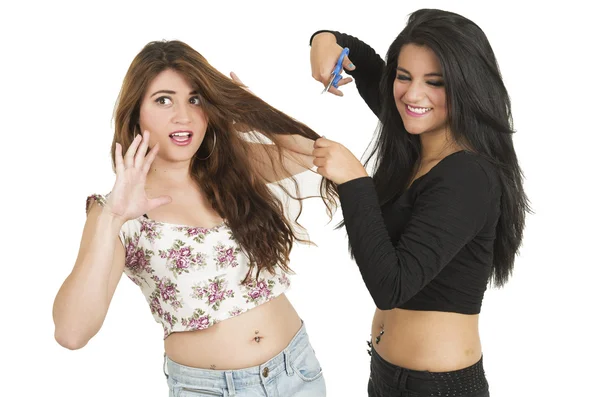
53, 41, 336, 396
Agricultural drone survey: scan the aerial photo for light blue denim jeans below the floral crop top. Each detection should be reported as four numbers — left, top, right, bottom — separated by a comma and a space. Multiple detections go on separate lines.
165, 322, 326, 397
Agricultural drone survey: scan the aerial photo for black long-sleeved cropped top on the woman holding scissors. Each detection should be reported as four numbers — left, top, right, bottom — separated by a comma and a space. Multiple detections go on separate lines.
311, 31, 501, 314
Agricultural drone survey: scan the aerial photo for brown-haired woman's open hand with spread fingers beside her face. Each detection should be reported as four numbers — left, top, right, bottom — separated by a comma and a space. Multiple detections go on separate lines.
105, 131, 171, 223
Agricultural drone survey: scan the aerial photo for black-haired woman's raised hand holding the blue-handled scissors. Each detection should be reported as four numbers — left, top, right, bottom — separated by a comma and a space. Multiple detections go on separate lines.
310, 32, 355, 96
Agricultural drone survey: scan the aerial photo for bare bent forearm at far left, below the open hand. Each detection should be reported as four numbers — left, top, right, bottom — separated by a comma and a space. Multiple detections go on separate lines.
53, 213, 121, 348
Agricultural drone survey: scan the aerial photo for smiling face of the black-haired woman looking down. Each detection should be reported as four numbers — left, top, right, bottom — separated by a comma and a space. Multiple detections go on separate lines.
394, 44, 448, 135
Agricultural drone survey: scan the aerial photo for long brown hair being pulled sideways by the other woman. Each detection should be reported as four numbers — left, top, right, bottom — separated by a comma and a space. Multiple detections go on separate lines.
111, 40, 337, 281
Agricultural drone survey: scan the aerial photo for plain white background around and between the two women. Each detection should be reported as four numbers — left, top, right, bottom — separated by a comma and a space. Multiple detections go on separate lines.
0, 0, 600, 397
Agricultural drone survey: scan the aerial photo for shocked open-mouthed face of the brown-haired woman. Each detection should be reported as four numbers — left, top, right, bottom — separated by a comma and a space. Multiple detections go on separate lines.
140, 69, 208, 162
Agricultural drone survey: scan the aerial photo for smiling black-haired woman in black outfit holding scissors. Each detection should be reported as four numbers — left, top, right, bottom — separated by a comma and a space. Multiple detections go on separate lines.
311, 9, 529, 397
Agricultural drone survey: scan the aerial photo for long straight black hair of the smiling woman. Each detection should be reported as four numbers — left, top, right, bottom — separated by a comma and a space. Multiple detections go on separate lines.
360, 9, 530, 287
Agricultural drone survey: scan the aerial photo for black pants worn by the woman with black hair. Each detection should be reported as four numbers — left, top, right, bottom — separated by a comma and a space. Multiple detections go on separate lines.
369, 349, 490, 397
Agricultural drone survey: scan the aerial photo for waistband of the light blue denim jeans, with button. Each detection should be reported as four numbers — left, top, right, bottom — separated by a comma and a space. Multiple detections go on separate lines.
165, 322, 310, 393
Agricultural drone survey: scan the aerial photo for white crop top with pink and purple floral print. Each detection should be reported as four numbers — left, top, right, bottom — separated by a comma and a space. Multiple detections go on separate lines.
86, 194, 290, 338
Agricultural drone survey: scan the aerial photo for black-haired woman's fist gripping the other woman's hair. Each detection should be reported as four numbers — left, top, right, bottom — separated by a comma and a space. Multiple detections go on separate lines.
312, 138, 369, 185
